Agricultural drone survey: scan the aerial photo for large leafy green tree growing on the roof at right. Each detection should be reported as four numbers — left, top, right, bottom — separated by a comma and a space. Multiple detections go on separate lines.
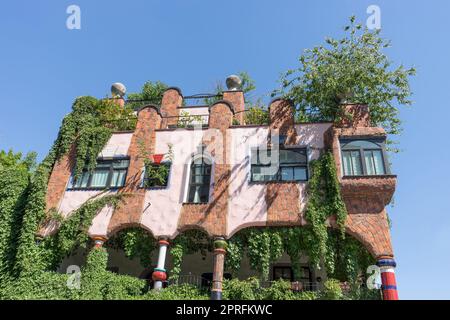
272, 17, 415, 134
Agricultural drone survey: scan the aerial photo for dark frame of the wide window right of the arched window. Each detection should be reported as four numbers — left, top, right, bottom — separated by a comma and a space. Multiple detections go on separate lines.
250, 145, 309, 183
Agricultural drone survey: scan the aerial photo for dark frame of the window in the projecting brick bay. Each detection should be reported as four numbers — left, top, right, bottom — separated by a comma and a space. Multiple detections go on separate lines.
339, 137, 391, 177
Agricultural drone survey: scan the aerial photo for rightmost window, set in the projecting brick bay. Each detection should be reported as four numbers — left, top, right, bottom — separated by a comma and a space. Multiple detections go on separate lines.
341, 140, 389, 176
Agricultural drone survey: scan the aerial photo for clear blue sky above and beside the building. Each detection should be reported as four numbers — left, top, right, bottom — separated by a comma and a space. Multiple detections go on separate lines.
0, 0, 450, 299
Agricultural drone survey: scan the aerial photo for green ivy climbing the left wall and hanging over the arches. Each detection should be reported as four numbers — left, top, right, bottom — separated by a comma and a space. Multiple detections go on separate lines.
0, 92, 380, 299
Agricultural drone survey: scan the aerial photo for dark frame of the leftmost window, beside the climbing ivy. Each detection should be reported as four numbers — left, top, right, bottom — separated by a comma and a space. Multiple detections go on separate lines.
67, 157, 130, 191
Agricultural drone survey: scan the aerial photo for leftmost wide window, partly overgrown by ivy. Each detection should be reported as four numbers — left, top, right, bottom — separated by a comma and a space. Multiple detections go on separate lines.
69, 159, 130, 189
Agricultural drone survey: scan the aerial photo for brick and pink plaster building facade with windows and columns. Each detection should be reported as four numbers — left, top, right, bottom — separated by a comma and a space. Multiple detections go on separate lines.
41, 88, 397, 299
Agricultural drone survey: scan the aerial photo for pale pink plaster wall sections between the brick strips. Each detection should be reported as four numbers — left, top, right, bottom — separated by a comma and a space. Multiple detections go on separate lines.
55, 124, 330, 238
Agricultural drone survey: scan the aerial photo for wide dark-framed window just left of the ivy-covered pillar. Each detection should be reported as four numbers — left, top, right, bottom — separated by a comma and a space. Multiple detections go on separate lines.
251, 148, 308, 182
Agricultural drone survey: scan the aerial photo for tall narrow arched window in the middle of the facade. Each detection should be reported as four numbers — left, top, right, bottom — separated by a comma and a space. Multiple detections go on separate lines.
187, 156, 211, 203
